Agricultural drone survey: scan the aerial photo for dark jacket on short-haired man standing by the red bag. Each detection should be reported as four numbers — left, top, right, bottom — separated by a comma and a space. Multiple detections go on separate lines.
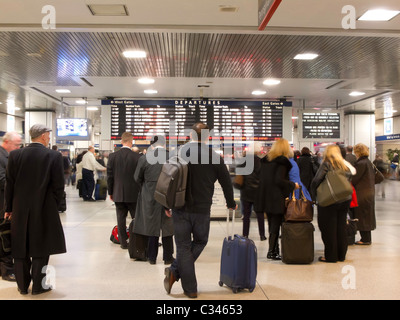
107, 148, 141, 202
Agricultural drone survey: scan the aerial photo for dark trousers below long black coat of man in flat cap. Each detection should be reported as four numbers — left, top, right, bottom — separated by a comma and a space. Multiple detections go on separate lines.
14, 256, 49, 291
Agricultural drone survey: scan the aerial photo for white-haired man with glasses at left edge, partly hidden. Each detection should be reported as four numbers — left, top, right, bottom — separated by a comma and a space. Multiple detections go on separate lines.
0, 132, 21, 281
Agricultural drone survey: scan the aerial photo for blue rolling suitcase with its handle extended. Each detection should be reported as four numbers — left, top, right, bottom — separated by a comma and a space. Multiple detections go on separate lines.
219, 211, 257, 293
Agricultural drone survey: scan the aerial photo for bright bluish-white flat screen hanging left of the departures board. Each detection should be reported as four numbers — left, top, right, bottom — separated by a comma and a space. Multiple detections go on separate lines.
57, 118, 89, 140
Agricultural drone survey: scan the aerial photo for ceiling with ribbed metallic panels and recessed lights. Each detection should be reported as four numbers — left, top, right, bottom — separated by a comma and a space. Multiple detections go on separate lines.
0, 0, 400, 134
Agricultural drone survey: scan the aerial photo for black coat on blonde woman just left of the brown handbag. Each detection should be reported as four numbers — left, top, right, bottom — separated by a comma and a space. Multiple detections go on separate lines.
254, 156, 295, 214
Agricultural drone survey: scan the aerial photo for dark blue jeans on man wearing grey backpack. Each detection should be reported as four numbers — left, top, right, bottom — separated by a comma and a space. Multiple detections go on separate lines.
170, 210, 210, 293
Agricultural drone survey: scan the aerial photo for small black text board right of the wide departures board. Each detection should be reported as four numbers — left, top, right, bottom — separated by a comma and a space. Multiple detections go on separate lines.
302, 112, 341, 140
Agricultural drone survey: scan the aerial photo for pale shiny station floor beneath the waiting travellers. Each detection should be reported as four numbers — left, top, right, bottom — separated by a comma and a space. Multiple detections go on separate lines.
0, 181, 400, 301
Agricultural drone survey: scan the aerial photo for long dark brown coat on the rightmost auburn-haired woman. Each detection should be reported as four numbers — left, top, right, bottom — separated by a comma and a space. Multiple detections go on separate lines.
352, 157, 376, 231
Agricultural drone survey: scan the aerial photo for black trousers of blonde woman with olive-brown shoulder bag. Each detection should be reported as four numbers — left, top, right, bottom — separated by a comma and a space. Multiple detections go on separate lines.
318, 201, 350, 262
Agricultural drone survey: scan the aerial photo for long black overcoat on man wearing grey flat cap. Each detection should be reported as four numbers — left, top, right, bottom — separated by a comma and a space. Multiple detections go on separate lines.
5, 143, 66, 258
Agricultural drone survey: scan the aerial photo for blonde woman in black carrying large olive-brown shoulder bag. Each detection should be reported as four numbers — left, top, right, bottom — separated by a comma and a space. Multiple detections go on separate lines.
310, 145, 351, 262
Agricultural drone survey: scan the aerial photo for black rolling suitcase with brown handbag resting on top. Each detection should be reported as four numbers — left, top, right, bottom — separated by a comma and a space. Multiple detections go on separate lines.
281, 222, 315, 264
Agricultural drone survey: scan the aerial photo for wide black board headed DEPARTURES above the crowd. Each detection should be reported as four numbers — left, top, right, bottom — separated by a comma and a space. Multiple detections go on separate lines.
102, 100, 291, 141
